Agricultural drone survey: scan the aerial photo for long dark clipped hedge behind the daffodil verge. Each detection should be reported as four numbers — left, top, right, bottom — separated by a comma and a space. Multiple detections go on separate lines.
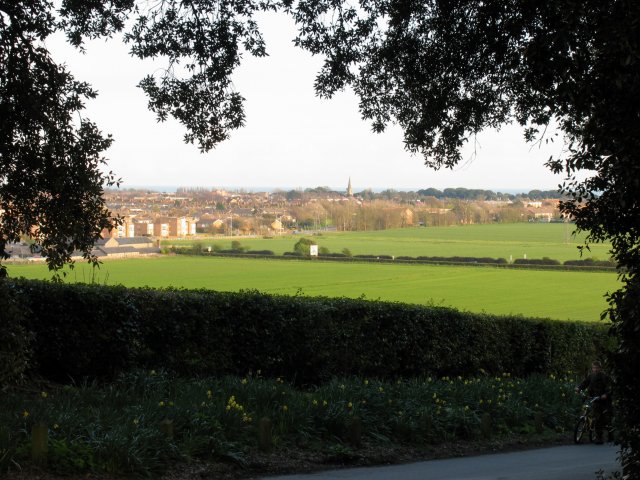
0, 279, 609, 384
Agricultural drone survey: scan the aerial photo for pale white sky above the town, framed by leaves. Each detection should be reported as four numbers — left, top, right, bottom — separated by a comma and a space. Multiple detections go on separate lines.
47, 10, 562, 192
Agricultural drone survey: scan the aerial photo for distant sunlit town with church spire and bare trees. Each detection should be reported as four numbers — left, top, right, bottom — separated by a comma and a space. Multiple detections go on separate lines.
105, 179, 562, 238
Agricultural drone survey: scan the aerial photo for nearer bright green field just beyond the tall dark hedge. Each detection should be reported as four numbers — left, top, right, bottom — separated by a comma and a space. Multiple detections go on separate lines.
8, 255, 618, 321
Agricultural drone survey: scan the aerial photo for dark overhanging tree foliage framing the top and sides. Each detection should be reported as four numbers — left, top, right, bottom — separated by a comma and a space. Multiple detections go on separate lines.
0, 0, 640, 474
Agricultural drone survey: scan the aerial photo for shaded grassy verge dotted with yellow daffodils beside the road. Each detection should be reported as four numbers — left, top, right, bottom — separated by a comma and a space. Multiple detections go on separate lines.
0, 372, 581, 479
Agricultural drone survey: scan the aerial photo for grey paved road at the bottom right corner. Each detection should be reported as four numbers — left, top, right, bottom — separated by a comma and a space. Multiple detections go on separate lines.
265, 444, 619, 480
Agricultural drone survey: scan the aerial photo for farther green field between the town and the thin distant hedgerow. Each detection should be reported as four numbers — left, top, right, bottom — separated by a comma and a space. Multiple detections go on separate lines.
168, 223, 611, 261
